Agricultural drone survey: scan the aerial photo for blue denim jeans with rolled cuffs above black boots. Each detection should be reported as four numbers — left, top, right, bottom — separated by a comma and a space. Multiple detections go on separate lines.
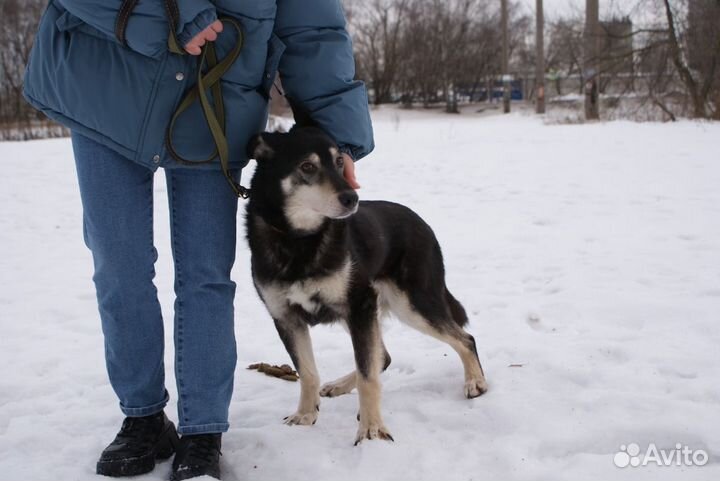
72, 133, 239, 434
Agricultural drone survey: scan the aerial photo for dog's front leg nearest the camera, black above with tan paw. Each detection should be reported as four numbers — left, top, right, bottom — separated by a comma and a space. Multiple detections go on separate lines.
348, 288, 393, 445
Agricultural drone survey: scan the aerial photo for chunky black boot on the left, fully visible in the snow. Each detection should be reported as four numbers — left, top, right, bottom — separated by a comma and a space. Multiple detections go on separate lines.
97, 412, 179, 476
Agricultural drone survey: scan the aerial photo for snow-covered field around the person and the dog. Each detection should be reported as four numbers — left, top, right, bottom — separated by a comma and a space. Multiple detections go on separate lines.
0, 110, 720, 481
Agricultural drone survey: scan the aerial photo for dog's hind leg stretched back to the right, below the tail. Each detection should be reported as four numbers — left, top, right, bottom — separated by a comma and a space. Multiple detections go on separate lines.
378, 282, 487, 398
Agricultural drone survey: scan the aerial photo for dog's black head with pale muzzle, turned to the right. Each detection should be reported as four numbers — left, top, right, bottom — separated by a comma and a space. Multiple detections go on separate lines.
248, 127, 358, 231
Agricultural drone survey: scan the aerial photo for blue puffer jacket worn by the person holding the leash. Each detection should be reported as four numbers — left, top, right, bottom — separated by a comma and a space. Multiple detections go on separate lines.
25, 0, 373, 169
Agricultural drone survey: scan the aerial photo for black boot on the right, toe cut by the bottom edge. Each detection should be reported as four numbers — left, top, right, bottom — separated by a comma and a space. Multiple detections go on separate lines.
170, 434, 222, 481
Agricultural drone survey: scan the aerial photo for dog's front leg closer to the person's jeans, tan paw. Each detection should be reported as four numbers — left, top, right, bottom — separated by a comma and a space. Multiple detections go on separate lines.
275, 319, 320, 425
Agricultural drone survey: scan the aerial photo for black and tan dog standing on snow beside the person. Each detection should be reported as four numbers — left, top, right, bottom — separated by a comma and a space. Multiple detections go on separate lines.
246, 123, 487, 444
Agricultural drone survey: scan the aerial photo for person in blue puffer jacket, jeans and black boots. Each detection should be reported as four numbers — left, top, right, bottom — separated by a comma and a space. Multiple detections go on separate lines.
24, 0, 373, 480
